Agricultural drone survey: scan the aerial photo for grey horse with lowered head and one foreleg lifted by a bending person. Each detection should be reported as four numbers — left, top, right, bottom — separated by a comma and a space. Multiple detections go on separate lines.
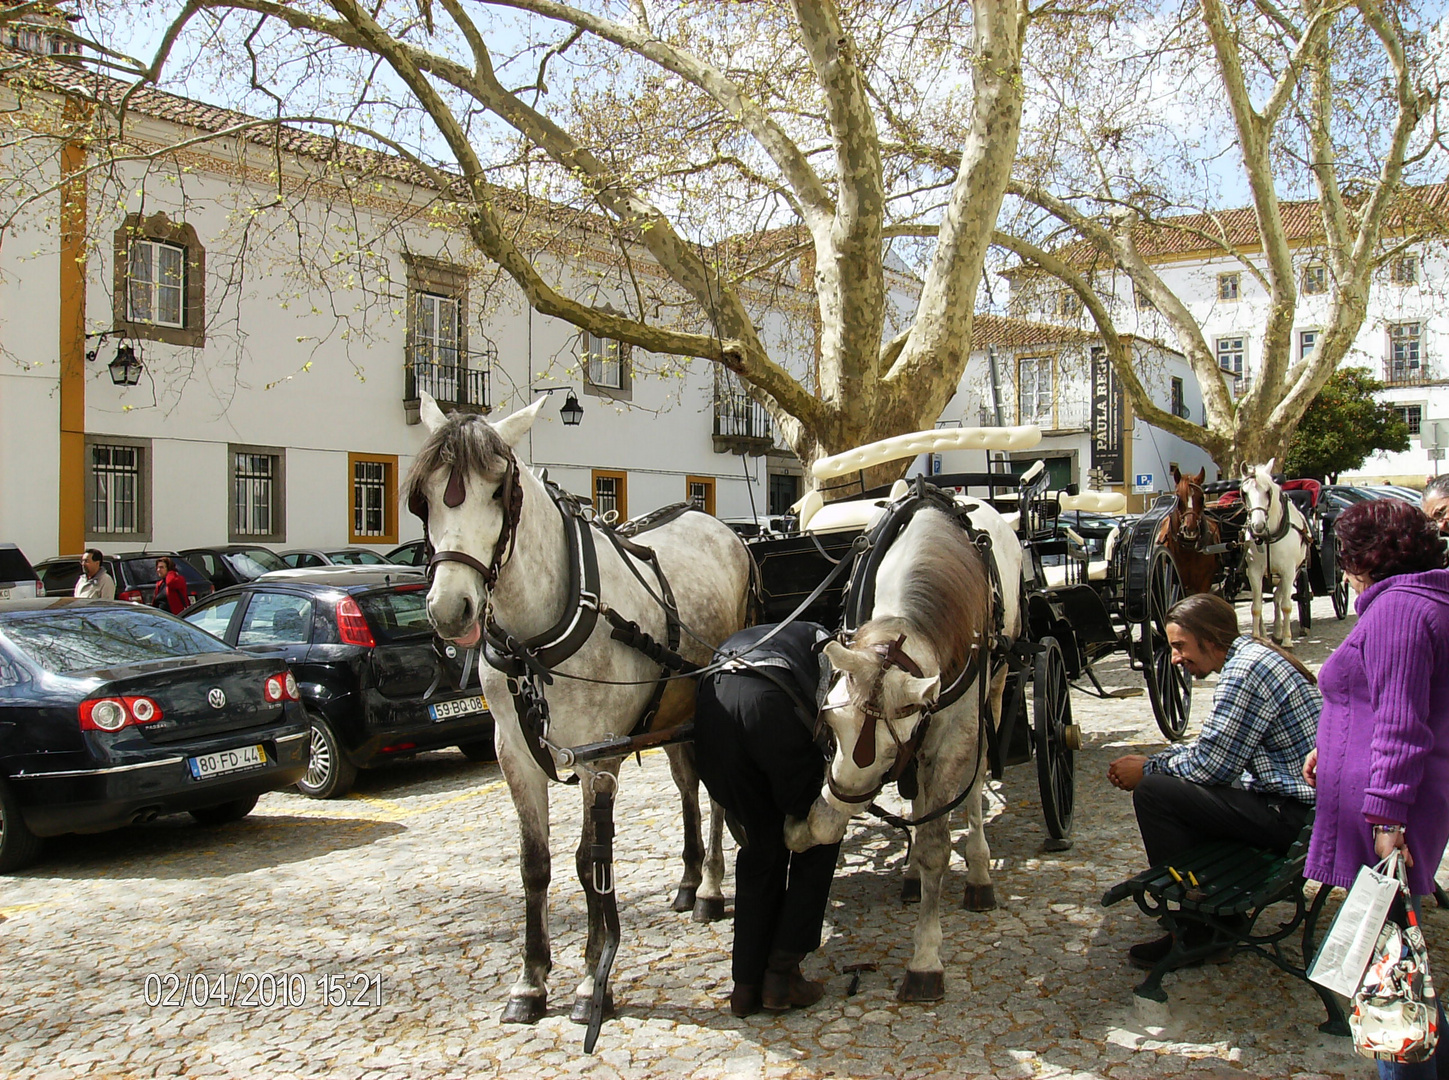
785, 499, 1022, 1002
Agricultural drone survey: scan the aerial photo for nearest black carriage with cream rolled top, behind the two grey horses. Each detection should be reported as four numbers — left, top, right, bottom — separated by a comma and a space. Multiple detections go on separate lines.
751, 428, 1217, 848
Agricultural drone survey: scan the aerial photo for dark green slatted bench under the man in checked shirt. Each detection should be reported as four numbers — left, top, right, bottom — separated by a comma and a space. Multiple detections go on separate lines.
1101, 819, 1349, 1035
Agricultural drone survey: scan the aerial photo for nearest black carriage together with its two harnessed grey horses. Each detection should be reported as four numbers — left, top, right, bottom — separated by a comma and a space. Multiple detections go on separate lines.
407, 396, 1321, 1050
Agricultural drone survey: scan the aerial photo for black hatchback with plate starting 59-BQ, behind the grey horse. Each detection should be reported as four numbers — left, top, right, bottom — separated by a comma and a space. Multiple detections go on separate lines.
183, 565, 493, 799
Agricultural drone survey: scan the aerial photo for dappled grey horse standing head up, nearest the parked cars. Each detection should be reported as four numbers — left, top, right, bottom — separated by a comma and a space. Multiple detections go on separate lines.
407, 394, 751, 1023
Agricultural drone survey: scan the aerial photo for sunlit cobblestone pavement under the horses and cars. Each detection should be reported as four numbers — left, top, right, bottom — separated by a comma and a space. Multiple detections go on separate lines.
0, 600, 1449, 1080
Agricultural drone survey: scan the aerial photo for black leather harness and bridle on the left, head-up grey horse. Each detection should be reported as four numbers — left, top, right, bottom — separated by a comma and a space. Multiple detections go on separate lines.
409, 452, 698, 784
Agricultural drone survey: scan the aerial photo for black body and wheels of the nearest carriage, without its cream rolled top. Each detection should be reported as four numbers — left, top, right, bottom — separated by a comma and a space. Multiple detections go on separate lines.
751, 465, 1191, 850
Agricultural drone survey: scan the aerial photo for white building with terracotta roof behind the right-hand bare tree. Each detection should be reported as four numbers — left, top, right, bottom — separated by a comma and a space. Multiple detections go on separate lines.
1009, 194, 1449, 487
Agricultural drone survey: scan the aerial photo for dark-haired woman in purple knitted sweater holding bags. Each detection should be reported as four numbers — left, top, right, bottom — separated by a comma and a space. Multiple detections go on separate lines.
1303, 499, 1449, 1079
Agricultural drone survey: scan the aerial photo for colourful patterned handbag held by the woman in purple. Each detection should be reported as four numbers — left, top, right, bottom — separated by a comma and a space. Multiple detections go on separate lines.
1349, 851, 1439, 1064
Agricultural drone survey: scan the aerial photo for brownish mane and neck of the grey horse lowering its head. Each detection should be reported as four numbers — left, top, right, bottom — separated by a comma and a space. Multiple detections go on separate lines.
851, 512, 991, 712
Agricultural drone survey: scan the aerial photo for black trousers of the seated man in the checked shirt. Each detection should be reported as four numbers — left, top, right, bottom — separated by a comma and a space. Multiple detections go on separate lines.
1132, 773, 1311, 865
